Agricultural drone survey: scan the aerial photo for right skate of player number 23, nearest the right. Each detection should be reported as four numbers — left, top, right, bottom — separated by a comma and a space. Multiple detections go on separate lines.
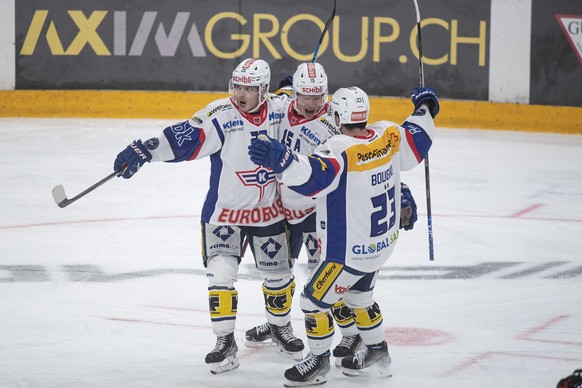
342, 341, 392, 377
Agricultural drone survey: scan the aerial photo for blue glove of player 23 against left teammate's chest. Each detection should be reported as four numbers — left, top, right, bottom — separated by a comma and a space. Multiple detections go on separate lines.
249, 135, 293, 174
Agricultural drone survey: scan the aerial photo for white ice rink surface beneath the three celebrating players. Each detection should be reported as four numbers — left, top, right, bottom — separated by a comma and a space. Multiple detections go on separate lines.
0, 119, 582, 388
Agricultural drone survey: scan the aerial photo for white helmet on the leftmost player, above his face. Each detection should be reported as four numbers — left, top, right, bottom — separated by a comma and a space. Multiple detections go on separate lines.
228, 58, 271, 105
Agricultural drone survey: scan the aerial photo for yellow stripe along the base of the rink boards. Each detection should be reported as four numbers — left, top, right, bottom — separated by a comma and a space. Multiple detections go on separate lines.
0, 90, 582, 135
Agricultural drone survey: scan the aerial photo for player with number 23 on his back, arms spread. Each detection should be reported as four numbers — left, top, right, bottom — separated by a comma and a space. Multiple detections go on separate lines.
249, 87, 439, 387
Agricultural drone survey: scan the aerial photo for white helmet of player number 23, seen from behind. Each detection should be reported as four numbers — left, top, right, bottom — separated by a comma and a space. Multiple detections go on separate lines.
330, 86, 370, 125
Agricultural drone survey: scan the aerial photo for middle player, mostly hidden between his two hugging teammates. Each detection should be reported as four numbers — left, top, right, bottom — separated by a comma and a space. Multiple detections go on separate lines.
245, 63, 416, 366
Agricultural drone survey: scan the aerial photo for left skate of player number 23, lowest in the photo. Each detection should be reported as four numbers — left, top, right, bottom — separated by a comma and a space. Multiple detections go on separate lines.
283, 350, 330, 387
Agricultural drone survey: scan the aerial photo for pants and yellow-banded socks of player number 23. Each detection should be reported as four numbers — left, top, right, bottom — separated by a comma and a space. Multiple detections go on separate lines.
301, 261, 384, 354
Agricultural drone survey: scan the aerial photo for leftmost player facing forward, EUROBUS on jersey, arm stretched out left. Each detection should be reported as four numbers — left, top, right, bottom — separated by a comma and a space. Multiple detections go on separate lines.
114, 58, 304, 374
